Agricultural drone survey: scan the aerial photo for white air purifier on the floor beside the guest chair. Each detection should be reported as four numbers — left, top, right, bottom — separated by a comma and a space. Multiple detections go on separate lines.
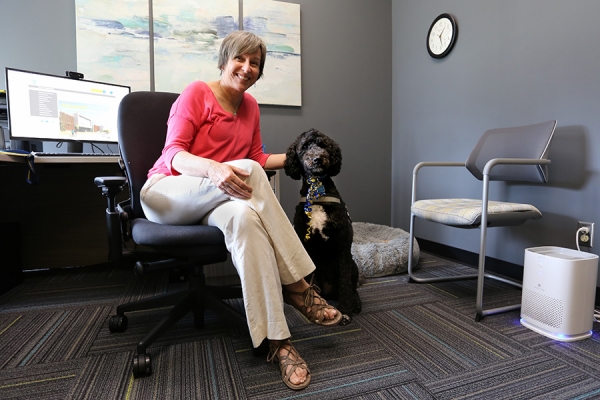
521, 246, 598, 342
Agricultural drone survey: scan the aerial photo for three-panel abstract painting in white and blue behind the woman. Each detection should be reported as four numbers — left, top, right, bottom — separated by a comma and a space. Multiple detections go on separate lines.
75, 0, 302, 106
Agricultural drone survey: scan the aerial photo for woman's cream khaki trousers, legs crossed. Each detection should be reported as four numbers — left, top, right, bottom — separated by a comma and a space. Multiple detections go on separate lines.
141, 160, 315, 347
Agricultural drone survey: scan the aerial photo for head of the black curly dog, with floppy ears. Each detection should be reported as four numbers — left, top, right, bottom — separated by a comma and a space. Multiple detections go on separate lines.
284, 129, 342, 179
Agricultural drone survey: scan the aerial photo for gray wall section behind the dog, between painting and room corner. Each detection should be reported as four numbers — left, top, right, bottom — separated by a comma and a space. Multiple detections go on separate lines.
261, 0, 392, 225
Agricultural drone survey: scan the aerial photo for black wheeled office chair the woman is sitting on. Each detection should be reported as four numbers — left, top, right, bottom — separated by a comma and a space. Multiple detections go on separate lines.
94, 92, 248, 377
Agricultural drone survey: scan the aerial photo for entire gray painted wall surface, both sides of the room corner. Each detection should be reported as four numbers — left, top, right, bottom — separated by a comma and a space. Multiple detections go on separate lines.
0, 0, 600, 282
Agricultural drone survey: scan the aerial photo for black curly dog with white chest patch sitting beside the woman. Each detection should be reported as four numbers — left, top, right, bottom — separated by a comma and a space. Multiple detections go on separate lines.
284, 129, 362, 323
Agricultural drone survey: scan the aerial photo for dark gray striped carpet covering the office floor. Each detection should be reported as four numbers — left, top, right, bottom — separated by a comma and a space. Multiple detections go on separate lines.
0, 253, 600, 399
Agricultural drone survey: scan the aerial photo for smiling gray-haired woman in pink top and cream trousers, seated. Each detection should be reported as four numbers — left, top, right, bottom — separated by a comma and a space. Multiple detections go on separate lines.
141, 31, 342, 389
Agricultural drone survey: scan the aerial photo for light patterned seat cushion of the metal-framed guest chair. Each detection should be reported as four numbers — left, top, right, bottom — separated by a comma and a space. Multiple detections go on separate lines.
411, 199, 542, 228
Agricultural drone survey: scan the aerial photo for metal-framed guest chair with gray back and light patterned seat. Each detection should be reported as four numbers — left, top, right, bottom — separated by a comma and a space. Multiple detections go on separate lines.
408, 120, 556, 321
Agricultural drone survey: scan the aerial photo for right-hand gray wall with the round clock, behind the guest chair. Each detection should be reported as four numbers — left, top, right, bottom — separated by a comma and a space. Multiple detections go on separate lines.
392, 0, 600, 282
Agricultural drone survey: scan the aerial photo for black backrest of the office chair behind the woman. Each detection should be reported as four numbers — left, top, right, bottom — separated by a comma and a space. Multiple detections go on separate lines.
118, 92, 179, 218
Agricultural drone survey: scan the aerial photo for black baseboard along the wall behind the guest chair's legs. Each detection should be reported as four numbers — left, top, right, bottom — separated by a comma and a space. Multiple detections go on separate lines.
417, 238, 600, 306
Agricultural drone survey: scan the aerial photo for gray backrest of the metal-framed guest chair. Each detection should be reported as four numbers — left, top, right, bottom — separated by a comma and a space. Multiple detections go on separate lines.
466, 120, 556, 183
